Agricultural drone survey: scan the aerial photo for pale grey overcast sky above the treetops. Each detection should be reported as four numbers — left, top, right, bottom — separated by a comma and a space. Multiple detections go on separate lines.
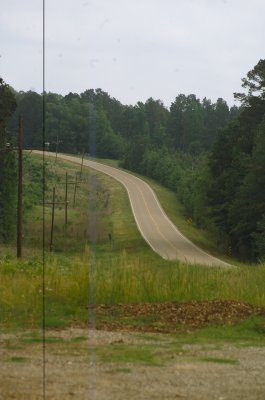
0, 0, 265, 106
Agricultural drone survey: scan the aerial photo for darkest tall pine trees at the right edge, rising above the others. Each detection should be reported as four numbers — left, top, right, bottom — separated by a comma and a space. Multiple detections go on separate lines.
207, 58, 265, 260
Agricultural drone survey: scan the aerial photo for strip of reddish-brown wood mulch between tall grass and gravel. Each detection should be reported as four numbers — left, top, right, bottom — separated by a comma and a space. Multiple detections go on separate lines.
95, 300, 265, 333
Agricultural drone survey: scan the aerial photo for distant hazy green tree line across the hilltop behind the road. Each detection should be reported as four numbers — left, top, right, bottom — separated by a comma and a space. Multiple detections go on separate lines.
8, 89, 239, 158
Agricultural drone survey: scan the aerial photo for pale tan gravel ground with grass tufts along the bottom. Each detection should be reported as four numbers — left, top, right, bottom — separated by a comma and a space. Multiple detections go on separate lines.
0, 329, 265, 400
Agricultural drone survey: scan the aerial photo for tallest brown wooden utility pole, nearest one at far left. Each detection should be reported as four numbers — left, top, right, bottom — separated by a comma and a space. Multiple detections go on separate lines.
17, 114, 23, 258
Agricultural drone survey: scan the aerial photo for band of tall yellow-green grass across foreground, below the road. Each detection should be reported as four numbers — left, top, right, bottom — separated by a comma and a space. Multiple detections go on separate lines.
0, 252, 265, 326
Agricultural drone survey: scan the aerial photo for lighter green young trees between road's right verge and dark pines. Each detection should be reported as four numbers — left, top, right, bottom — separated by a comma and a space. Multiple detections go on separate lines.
121, 147, 209, 231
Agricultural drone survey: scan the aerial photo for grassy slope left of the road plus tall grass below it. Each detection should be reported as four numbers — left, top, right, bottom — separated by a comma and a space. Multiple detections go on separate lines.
0, 156, 265, 340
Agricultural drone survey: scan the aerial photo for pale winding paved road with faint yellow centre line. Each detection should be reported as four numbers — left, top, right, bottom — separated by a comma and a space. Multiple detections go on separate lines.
35, 151, 229, 266
